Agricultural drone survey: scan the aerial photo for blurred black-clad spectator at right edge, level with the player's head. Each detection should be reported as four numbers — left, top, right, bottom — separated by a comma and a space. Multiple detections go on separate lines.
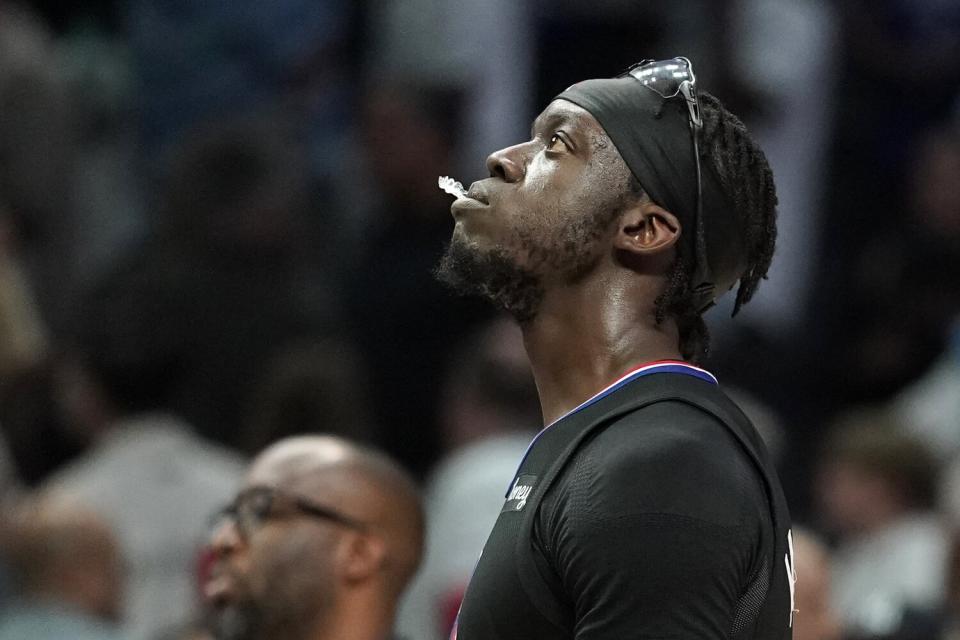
838, 126, 960, 400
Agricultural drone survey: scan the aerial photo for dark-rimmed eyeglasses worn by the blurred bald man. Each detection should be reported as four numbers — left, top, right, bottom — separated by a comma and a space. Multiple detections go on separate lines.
214, 487, 367, 540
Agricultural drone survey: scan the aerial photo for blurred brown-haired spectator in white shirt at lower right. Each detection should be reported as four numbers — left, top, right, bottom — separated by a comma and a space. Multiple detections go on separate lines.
817, 410, 949, 637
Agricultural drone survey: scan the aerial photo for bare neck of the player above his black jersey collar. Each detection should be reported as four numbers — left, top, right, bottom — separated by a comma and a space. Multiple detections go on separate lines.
523, 272, 681, 424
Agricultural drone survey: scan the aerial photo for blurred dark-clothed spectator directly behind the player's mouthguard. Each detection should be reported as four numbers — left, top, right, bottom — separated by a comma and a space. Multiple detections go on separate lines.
347, 82, 490, 470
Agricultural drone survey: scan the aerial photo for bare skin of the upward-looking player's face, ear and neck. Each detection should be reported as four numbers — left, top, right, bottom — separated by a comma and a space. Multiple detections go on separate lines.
451, 100, 681, 424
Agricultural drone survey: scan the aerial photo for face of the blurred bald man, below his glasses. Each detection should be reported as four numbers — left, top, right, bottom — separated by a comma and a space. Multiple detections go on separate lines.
204, 471, 341, 640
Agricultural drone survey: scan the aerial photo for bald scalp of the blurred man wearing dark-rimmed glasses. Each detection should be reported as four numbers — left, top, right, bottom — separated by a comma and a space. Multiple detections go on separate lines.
245, 436, 424, 593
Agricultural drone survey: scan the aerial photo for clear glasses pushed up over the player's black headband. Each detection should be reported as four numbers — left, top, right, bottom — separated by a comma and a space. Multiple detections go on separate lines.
622, 57, 713, 306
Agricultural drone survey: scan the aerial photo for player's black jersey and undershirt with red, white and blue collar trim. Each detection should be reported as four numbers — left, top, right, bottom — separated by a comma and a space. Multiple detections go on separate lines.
452, 373, 795, 640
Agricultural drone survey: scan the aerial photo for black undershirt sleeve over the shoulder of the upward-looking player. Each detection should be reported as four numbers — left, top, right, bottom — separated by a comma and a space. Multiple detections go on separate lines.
534, 402, 769, 638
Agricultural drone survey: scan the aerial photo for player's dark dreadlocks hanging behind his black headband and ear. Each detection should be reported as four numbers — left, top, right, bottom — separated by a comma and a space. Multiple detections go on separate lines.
648, 92, 777, 362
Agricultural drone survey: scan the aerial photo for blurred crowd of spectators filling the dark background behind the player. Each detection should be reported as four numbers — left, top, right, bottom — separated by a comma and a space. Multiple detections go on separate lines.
0, 0, 960, 640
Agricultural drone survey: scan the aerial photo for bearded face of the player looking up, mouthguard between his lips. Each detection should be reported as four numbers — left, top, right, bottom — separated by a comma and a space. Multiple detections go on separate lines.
438, 100, 630, 322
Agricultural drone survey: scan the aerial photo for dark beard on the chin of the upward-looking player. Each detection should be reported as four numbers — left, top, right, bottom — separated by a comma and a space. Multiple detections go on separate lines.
434, 238, 543, 324
